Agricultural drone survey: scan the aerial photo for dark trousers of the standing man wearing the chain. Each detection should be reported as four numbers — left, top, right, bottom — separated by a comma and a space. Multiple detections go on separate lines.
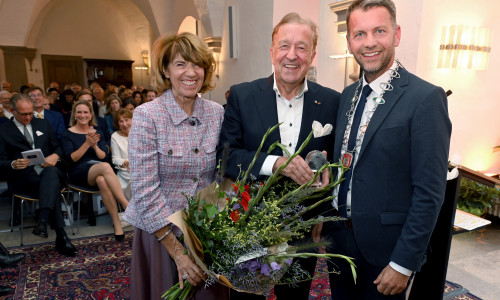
322, 221, 410, 300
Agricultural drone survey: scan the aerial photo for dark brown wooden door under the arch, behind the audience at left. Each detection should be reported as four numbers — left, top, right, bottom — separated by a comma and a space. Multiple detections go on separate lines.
42, 54, 85, 92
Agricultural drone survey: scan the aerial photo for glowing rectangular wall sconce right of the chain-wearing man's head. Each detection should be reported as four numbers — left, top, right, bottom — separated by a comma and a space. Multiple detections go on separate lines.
437, 25, 491, 70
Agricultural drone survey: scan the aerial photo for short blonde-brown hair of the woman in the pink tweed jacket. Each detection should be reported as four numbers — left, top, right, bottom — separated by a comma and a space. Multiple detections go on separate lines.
151, 32, 215, 93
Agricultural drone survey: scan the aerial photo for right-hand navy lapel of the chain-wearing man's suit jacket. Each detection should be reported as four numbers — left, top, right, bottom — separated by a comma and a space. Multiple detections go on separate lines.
358, 68, 408, 159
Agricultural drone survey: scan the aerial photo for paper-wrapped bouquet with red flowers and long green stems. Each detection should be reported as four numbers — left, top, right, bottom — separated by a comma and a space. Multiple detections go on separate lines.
163, 124, 356, 299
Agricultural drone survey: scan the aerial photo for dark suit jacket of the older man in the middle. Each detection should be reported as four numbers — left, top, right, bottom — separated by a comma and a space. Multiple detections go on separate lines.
217, 75, 340, 179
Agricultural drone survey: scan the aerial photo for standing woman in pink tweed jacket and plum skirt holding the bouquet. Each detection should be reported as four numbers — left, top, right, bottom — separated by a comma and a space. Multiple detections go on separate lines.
124, 33, 229, 299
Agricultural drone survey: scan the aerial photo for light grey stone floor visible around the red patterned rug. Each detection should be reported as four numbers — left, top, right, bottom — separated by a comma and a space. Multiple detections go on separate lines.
0, 183, 500, 300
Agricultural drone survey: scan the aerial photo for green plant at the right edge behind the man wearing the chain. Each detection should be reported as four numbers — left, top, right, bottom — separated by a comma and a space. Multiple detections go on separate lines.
457, 178, 500, 216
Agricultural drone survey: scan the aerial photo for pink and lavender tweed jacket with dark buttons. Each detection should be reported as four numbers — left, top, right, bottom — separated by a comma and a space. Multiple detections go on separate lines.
124, 90, 224, 233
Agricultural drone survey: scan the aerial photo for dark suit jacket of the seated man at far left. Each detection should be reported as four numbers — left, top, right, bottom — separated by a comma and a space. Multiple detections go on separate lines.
0, 118, 63, 181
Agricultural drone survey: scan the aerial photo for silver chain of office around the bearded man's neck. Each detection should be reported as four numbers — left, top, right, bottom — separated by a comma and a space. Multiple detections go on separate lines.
342, 59, 403, 168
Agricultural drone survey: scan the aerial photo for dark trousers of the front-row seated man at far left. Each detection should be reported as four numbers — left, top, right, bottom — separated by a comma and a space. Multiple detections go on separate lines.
8, 167, 66, 229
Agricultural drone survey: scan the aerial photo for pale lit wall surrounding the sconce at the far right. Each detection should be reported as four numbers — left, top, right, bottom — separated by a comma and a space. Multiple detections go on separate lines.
417, 0, 500, 172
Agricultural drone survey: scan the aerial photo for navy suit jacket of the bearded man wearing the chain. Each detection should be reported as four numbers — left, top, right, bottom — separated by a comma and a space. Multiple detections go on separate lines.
334, 68, 451, 271
